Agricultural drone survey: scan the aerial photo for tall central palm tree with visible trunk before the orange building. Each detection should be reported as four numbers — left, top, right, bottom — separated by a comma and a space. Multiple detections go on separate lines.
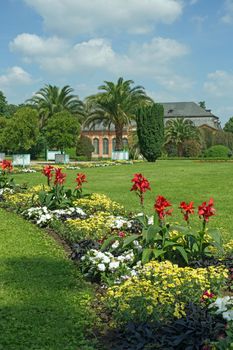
84, 78, 152, 151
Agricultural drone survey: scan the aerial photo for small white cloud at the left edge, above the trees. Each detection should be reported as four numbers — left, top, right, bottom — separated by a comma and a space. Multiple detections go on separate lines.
0, 66, 33, 90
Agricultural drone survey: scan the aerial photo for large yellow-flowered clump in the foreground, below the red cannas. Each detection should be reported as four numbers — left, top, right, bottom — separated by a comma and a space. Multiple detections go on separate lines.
105, 261, 228, 323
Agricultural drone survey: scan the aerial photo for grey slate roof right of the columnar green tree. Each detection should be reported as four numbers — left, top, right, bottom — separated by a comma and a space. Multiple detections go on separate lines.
161, 102, 218, 119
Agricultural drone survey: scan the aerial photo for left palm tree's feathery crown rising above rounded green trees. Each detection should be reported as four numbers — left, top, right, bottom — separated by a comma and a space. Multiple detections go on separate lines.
27, 85, 83, 127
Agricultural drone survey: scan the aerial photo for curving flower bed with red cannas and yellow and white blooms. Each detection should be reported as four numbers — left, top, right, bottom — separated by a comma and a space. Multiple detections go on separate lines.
0, 162, 233, 349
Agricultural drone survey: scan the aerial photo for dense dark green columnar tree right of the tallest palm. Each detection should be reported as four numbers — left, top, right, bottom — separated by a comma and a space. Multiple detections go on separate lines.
136, 103, 164, 162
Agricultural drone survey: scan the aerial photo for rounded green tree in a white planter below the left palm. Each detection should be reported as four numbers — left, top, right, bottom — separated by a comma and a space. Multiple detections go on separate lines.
45, 111, 81, 153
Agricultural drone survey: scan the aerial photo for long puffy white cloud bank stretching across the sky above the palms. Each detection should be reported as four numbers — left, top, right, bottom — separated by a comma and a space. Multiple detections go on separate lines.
10, 33, 192, 91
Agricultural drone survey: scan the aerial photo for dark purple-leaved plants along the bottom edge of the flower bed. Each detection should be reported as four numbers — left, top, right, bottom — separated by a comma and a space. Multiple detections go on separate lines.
107, 303, 226, 350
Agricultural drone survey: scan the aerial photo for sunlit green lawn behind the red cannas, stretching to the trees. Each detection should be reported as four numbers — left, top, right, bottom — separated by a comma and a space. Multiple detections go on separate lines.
16, 160, 233, 239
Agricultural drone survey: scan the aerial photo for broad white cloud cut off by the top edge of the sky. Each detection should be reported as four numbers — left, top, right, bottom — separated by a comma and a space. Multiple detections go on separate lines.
24, 0, 183, 36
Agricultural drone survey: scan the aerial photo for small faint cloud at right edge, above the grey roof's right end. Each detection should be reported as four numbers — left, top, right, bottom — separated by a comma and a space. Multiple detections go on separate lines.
204, 70, 233, 97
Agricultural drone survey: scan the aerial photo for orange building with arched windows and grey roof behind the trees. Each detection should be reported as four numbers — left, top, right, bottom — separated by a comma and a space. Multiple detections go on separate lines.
82, 102, 221, 158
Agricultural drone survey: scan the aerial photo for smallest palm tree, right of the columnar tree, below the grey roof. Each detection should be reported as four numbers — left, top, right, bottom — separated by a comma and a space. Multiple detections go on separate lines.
165, 118, 200, 157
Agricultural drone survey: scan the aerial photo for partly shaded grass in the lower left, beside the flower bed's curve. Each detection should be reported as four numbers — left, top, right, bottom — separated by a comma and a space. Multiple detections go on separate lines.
0, 210, 97, 350
